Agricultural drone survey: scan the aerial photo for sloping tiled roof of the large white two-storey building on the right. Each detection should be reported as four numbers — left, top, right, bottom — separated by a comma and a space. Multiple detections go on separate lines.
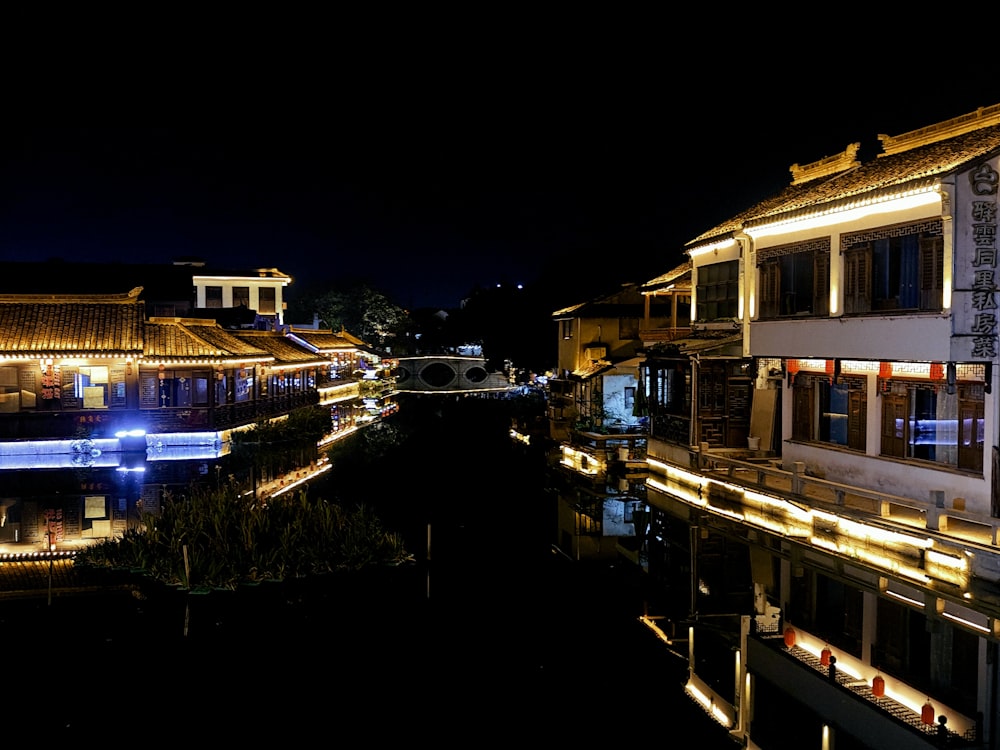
686, 119, 1000, 247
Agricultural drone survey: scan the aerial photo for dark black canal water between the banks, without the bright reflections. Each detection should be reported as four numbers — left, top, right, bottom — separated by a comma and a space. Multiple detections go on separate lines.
0, 396, 734, 750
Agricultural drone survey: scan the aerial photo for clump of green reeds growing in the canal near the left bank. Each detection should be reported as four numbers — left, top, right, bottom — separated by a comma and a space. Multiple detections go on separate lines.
74, 485, 413, 589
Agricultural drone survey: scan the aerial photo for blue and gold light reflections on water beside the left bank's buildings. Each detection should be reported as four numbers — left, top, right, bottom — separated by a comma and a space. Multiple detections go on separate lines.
0, 433, 332, 552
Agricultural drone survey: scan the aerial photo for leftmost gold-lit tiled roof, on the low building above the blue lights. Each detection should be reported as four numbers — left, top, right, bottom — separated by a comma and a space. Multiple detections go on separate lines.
0, 294, 144, 357
